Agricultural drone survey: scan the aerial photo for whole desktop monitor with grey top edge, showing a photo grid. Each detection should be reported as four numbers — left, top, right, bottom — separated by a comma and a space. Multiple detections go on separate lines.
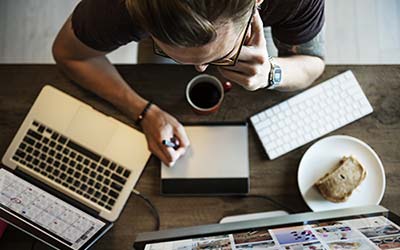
134, 206, 400, 250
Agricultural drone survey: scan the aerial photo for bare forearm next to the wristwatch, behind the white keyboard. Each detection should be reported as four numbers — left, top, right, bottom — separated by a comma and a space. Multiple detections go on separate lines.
274, 55, 325, 91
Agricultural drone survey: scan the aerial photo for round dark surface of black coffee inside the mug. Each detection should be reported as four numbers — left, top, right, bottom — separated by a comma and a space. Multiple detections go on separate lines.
189, 82, 221, 109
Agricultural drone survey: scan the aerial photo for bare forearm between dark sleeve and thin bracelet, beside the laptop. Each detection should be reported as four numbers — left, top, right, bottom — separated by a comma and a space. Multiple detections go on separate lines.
56, 56, 147, 119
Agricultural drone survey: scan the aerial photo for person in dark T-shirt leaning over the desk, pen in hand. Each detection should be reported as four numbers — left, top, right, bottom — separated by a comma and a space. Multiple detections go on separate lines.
52, 0, 324, 166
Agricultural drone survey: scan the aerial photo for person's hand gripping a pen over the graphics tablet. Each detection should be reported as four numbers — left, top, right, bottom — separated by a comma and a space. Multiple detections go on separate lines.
141, 104, 190, 167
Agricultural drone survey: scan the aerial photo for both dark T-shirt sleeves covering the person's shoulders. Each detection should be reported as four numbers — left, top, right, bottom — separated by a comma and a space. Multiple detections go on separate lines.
72, 0, 324, 51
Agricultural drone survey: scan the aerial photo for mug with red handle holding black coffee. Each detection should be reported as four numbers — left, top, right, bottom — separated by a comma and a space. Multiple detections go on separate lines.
186, 74, 232, 115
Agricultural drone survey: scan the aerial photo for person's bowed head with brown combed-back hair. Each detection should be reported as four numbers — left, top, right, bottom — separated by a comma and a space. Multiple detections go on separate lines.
126, 0, 261, 70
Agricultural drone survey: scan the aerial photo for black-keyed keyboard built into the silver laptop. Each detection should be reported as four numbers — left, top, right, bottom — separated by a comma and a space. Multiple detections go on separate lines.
12, 121, 131, 210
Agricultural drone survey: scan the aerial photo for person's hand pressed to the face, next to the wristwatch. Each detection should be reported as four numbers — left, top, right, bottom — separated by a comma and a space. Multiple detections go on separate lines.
218, 11, 271, 91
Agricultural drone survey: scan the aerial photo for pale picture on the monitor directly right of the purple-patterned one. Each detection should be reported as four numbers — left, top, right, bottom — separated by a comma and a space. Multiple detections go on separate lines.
315, 226, 359, 242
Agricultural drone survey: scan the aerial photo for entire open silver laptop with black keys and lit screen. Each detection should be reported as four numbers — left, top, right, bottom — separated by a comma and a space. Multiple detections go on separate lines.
0, 85, 150, 249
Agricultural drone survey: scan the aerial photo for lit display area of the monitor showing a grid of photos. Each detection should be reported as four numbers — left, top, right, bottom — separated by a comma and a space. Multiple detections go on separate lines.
134, 207, 400, 250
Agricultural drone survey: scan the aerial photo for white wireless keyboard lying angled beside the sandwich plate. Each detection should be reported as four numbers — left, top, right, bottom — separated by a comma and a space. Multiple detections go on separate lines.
250, 71, 373, 160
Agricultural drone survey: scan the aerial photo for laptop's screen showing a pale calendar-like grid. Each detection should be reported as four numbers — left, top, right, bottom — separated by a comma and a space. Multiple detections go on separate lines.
0, 168, 110, 249
